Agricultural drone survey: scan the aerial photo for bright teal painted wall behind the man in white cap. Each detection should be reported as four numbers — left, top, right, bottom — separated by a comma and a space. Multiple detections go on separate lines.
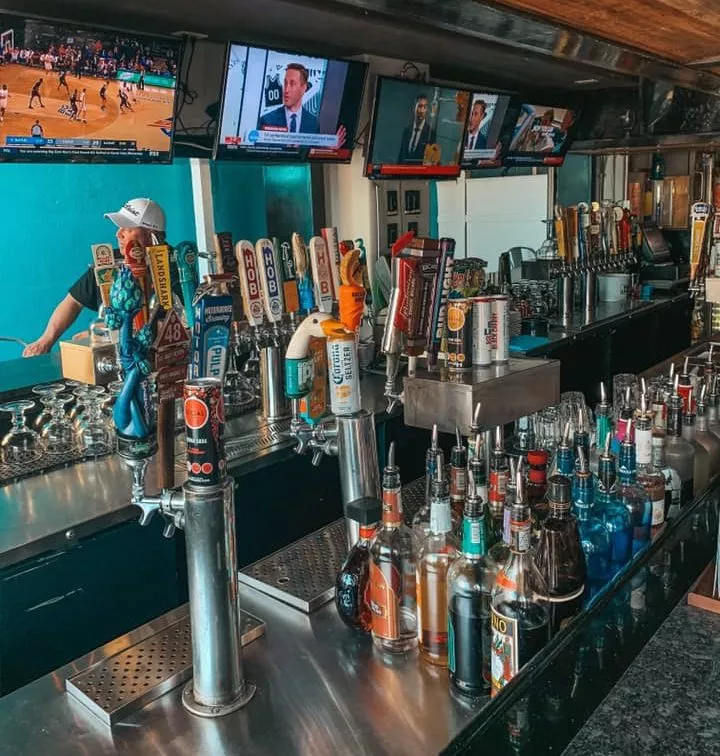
0, 159, 312, 360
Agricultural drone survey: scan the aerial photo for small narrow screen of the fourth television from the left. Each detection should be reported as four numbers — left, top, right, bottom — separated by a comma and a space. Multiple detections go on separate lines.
460, 92, 517, 170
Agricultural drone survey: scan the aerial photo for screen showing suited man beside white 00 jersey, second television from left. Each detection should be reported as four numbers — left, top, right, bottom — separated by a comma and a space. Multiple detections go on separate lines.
215, 43, 367, 162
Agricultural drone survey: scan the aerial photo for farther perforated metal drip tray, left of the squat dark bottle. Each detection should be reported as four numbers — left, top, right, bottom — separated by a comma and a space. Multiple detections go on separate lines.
240, 518, 347, 612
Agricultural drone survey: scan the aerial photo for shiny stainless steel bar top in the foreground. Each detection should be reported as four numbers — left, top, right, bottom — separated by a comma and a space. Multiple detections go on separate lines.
0, 586, 484, 756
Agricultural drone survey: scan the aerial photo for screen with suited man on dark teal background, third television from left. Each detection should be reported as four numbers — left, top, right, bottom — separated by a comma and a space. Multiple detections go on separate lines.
365, 76, 470, 179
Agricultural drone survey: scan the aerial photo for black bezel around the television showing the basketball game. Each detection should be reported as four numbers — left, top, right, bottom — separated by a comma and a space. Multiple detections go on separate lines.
0, 11, 183, 165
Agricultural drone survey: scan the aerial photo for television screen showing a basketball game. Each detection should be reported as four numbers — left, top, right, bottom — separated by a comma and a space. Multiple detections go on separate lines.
0, 14, 182, 163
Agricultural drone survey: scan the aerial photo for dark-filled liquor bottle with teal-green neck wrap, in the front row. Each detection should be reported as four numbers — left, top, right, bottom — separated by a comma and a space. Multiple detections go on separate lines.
447, 476, 494, 696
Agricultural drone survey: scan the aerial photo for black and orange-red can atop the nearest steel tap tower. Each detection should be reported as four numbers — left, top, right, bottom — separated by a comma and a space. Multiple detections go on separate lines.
183, 378, 226, 488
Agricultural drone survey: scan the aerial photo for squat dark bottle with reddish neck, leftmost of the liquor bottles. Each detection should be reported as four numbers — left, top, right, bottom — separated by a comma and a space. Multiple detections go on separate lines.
335, 522, 377, 633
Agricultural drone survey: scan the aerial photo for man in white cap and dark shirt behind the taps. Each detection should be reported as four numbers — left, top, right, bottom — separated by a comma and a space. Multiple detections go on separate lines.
23, 198, 165, 357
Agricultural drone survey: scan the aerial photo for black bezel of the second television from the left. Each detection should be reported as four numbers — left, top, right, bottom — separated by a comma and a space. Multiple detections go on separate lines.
212, 40, 370, 165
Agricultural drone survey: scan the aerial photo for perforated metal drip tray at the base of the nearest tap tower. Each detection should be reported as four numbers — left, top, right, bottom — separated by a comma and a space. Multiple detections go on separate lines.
65, 611, 265, 725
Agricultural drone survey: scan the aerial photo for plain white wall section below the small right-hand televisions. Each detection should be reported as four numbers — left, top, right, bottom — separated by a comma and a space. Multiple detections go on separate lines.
437, 175, 547, 272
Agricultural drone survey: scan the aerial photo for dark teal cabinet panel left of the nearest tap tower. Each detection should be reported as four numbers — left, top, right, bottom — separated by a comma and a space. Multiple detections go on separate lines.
0, 518, 179, 695
